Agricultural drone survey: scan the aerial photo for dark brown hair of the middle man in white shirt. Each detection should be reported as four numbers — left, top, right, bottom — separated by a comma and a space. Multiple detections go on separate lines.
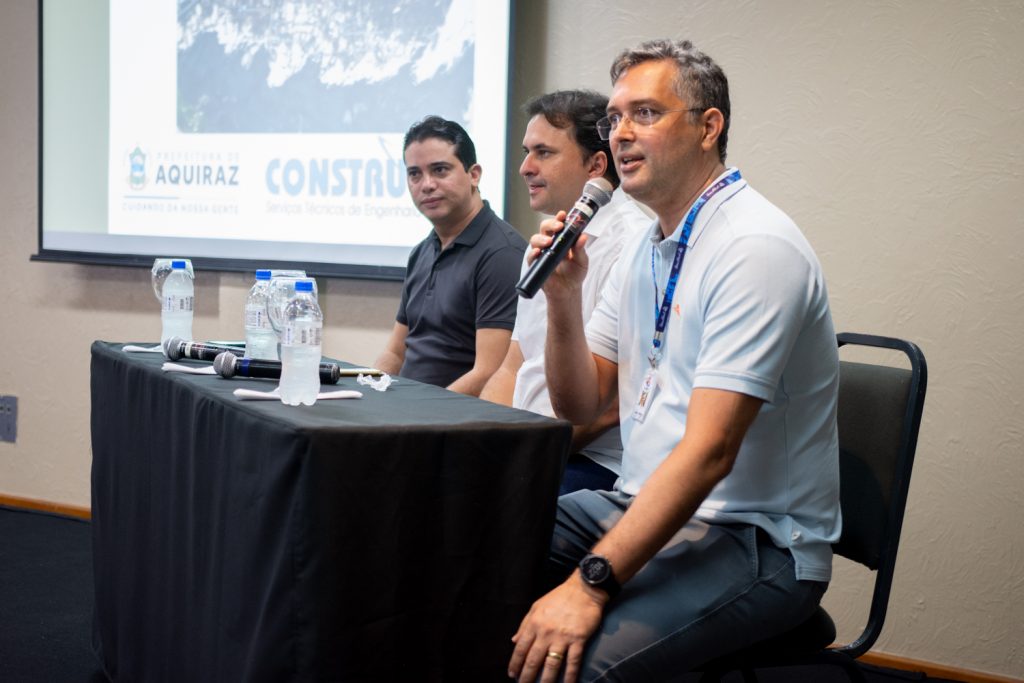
522, 90, 618, 187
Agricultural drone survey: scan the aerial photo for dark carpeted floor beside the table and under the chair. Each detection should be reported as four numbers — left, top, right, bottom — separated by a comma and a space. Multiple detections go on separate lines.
0, 506, 955, 683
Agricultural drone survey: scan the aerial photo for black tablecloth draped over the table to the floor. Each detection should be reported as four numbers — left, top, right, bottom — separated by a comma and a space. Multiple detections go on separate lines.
92, 342, 570, 682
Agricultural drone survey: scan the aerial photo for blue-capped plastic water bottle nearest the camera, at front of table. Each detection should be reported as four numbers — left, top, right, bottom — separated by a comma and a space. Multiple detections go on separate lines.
280, 280, 324, 405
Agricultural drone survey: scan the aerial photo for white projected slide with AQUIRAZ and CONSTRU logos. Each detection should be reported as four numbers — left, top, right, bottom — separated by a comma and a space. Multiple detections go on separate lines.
43, 0, 508, 278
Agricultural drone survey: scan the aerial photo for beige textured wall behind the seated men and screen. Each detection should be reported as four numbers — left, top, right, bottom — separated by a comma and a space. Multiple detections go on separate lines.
0, 0, 1024, 677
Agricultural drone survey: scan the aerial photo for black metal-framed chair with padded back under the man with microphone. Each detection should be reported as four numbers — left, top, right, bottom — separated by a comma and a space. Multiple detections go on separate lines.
699, 333, 928, 683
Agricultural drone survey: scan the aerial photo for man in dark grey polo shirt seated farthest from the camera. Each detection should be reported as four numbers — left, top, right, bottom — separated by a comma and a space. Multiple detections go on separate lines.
375, 117, 526, 396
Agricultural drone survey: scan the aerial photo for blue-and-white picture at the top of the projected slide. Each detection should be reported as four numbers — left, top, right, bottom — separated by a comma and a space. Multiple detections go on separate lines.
177, 0, 475, 133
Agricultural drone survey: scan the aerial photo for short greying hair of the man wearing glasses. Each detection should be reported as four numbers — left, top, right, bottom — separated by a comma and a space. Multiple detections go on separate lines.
611, 38, 732, 163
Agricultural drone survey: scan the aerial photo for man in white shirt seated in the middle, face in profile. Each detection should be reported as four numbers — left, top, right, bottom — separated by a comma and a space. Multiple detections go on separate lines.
480, 90, 651, 494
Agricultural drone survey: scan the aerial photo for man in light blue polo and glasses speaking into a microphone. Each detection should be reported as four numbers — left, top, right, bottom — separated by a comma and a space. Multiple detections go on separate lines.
509, 41, 840, 682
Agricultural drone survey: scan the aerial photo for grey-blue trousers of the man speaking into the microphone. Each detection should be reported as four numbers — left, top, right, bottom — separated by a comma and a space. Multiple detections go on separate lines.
549, 490, 827, 681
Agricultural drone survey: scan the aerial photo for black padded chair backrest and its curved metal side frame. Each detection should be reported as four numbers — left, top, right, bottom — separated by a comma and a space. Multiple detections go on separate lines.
834, 333, 928, 657
